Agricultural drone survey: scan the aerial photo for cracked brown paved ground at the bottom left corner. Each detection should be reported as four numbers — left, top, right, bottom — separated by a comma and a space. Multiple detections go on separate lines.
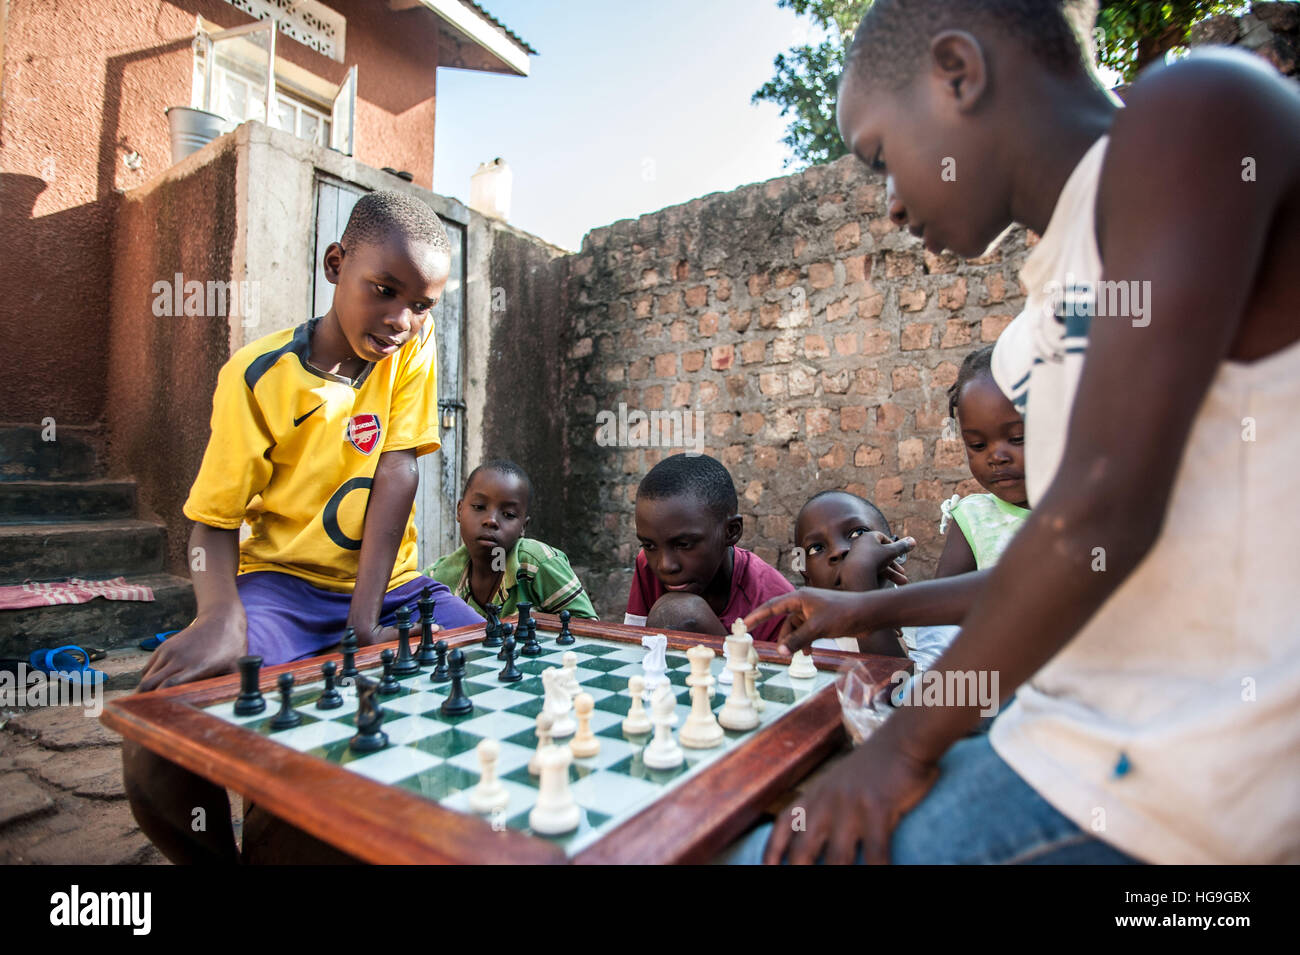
0, 650, 239, 865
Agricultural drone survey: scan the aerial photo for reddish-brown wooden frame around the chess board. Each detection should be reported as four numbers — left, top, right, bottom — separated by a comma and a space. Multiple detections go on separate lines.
100, 613, 907, 864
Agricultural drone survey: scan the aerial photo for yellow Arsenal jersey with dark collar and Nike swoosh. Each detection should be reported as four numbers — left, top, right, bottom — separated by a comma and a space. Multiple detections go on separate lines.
185, 318, 438, 592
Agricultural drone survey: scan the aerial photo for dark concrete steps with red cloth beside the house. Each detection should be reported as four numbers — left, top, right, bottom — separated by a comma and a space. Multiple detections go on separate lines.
0, 426, 195, 657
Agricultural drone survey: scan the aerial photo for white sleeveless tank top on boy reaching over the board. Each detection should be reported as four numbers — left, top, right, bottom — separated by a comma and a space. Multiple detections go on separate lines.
991, 138, 1300, 863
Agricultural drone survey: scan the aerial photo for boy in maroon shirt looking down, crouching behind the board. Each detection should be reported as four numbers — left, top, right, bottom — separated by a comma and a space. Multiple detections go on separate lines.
623, 453, 794, 642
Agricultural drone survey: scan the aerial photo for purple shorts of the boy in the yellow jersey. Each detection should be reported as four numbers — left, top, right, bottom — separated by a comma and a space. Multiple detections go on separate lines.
235, 570, 484, 667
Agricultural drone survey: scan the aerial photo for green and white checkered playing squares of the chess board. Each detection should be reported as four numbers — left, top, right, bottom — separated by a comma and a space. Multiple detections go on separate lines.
207, 631, 833, 855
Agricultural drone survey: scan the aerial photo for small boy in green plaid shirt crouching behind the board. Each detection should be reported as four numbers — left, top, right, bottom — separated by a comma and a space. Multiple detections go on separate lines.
425, 460, 595, 620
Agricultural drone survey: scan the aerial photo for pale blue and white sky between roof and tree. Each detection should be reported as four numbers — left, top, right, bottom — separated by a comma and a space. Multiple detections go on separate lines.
433, 0, 819, 249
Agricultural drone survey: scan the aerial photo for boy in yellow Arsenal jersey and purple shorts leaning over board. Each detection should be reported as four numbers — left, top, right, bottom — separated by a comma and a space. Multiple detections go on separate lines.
124, 192, 481, 861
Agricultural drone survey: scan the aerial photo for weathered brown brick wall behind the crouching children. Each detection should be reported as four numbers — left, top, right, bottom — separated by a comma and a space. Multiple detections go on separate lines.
556, 157, 1032, 616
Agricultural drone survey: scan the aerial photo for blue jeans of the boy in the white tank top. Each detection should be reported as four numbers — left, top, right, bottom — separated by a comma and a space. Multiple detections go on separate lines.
718, 734, 1138, 865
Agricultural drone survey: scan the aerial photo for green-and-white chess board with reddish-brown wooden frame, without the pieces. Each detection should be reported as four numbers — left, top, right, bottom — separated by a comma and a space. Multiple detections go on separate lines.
104, 615, 904, 861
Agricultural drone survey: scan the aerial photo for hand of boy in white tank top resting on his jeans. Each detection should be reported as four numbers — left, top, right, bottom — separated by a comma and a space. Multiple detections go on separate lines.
763, 722, 939, 865
